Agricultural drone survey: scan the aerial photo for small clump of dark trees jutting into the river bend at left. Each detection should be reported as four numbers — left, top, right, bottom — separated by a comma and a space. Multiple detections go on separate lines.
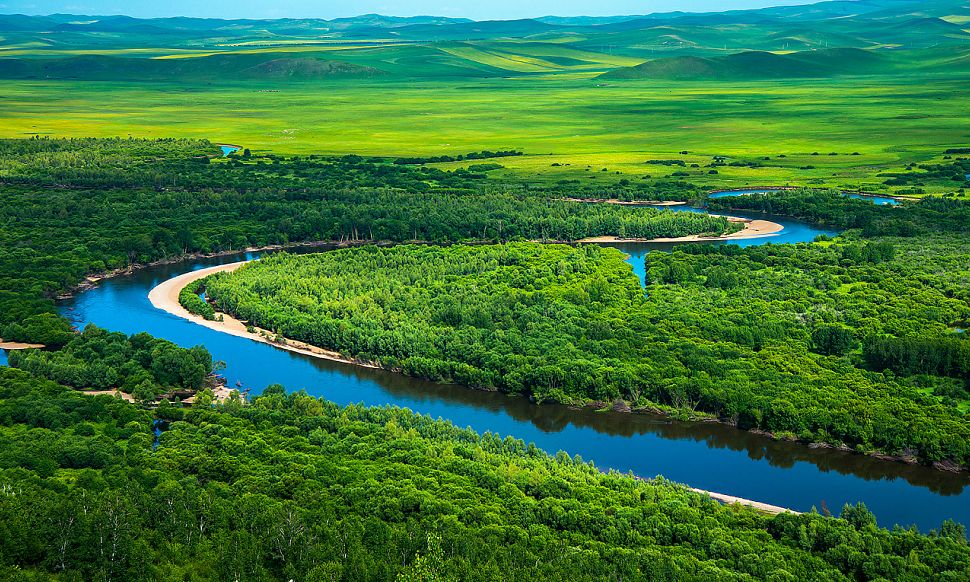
9, 325, 213, 401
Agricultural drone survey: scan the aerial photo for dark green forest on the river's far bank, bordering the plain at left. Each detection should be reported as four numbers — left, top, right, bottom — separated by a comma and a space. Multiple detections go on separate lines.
0, 139, 732, 345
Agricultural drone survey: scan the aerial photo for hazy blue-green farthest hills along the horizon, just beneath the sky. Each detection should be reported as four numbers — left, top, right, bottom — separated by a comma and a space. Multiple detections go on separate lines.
0, 0, 970, 60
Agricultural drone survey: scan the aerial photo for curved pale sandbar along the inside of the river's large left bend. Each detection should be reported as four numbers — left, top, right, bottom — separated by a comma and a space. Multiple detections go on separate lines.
148, 261, 378, 368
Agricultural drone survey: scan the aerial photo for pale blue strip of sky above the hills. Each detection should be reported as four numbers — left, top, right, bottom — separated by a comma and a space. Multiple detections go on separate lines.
0, 0, 812, 20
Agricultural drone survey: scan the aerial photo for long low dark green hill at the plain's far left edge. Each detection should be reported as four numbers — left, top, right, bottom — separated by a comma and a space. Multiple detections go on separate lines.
0, 53, 384, 81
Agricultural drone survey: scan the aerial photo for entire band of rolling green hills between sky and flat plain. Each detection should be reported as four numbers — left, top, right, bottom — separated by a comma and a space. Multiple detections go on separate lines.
0, 0, 970, 78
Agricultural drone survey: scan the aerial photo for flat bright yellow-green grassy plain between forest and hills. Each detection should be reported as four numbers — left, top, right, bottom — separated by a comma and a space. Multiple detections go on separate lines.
0, 74, 970, 192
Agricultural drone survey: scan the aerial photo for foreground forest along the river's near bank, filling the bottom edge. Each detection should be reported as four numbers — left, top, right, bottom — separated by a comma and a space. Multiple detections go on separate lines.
0, 369, 970, 581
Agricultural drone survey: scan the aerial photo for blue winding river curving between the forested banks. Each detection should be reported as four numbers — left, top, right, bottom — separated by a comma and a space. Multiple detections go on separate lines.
47, 201, 970, 531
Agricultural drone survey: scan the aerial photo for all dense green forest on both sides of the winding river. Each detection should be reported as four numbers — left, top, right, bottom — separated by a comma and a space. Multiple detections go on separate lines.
0, 139, 970, 581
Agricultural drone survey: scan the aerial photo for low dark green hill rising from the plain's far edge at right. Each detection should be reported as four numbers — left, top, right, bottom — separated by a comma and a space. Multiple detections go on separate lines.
600, 48, 889, 80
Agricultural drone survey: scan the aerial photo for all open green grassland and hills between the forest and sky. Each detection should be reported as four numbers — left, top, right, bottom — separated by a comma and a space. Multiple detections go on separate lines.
0, 0, 970, 194
